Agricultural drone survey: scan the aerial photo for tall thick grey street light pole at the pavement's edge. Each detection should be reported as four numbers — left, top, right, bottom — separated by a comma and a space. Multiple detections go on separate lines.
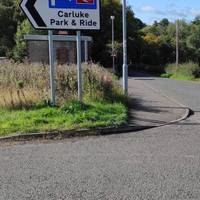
122, 0, 128, 95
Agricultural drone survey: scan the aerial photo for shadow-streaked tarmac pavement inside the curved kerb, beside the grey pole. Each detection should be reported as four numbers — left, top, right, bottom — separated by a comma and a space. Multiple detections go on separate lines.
129, 78, 188, 126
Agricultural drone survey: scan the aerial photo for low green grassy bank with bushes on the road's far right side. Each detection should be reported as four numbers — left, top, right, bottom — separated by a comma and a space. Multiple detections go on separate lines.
161, 62, 200, 81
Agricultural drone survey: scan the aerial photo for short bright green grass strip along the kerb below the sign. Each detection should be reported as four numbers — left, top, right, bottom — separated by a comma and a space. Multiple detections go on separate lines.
0, 101, 127, 136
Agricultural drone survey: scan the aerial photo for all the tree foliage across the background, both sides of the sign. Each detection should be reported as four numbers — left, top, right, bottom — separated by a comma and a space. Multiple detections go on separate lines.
0, 0, 200, 71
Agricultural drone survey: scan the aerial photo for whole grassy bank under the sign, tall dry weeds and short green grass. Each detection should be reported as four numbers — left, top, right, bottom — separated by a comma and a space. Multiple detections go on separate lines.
0, 63, 127, 136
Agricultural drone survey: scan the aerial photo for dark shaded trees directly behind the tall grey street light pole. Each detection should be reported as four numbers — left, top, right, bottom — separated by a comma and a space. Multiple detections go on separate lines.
85, 0, 144, 68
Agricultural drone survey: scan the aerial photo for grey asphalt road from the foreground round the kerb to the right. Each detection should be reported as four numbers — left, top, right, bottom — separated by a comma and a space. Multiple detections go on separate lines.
0, 78, 200, 200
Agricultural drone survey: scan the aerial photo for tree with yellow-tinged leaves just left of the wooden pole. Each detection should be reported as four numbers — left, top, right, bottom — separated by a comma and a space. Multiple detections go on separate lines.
140, 19, 175, 65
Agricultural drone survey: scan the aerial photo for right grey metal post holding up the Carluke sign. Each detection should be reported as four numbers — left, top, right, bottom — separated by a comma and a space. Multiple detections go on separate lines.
76, 31, 83, 101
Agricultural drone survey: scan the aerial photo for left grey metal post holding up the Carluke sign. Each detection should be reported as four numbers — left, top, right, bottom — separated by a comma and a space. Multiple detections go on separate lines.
48, 31, 56, 106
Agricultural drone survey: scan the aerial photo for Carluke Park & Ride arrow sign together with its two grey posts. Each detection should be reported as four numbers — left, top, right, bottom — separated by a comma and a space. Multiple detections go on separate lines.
20, 0, 100, 105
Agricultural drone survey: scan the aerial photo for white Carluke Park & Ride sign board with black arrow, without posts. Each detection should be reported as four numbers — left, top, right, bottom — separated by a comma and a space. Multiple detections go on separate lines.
20, 0, 100, 30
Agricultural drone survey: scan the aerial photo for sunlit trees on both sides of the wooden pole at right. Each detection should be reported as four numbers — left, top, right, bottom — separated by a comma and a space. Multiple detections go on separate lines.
140, 17, 200, 65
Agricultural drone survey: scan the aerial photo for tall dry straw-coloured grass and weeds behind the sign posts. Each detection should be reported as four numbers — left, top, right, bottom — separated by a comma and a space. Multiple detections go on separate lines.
0, 62, 123, 109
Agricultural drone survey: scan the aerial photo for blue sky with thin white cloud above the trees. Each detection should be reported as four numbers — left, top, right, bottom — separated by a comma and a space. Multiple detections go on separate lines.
127, 0, 200, 24
